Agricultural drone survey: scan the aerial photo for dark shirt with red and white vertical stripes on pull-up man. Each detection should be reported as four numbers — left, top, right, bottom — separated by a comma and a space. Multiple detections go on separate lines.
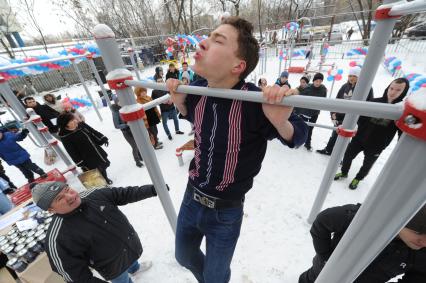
185, 79, 307, 200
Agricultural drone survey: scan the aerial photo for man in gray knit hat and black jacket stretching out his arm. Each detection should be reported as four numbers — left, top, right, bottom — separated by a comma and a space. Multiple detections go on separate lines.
31, 182, 157, 283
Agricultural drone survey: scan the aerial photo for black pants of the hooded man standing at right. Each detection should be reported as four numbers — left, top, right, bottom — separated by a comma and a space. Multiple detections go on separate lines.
342, 139, 380, 180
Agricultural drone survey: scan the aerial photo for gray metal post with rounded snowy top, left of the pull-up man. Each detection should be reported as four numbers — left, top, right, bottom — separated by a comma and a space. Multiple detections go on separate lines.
93, 24, 177, 233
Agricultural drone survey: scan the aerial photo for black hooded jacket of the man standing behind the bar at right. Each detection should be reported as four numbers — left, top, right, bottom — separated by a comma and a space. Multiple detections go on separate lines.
354, 79, 410, 153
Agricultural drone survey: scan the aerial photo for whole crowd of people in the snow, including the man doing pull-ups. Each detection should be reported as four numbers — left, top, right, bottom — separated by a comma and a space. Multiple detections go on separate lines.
0, 17, 426, 283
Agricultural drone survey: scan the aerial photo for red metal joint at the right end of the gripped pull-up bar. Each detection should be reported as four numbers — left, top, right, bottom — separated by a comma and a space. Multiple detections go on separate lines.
396, 97, 426, 141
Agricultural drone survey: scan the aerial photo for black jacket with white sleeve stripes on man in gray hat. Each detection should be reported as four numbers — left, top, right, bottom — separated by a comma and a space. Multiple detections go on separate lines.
45, 185, 155, 283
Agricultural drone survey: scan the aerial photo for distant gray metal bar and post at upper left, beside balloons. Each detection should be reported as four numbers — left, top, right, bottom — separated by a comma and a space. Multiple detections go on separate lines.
0, 55, 105, 121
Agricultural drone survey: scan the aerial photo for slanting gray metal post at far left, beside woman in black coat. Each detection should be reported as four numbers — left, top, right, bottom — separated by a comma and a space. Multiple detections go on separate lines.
0, 78, 78, 175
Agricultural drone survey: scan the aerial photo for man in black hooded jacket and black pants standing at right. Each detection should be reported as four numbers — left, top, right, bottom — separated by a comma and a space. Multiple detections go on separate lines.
334, 78, 410, 190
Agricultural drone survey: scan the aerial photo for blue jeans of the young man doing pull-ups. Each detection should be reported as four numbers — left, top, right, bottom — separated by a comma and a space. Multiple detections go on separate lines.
175, 185, 243, 283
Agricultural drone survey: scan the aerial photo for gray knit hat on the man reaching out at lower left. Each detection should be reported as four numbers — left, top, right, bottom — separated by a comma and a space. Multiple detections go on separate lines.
31, 182, 68, 210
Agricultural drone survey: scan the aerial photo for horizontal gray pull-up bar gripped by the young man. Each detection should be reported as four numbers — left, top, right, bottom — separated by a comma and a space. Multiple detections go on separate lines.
125, 80, 403, 120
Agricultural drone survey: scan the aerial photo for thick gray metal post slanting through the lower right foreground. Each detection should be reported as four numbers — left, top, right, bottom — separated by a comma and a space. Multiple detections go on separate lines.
315, 134, 426, 283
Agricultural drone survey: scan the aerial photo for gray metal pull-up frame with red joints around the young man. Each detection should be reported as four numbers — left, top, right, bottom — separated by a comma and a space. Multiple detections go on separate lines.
94, 0, 426, 283
